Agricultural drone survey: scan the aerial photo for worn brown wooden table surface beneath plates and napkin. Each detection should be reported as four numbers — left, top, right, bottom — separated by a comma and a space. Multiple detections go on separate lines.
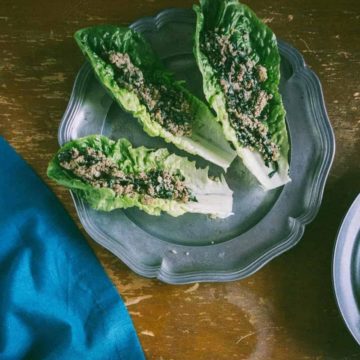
0, 0, 360, 360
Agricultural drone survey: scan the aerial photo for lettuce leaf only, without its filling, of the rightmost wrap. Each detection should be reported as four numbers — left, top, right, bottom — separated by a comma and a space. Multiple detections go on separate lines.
194, 0, 290, 189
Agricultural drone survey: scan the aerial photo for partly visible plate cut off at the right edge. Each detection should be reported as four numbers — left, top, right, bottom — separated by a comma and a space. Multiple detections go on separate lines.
333, 194, 360, 345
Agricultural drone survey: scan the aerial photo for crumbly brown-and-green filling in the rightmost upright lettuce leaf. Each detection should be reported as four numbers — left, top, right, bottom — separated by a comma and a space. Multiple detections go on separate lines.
200, 28, 280, 167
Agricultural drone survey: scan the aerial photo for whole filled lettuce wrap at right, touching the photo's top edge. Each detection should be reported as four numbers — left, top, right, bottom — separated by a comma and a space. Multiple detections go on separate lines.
194, 0, 290, 190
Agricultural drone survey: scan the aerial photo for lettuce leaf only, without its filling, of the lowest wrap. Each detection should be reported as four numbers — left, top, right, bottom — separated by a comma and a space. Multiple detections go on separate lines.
47, 135, 232, 218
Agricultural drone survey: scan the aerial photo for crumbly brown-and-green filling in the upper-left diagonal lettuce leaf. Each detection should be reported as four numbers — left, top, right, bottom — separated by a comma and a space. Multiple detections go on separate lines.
108, 52, 194, 136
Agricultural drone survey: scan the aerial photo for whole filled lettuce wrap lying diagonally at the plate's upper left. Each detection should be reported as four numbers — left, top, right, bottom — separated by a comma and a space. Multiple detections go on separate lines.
75, 25, 236, 169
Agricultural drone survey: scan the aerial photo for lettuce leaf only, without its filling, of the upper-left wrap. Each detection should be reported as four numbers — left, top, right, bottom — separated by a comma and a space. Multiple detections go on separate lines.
75, 25, 236, 169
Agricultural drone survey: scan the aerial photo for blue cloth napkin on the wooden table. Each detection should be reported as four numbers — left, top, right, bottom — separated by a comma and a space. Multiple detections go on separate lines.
0, 137, 144, 360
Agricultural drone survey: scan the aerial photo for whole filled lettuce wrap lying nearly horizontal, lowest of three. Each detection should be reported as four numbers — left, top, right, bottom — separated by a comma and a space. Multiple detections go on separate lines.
47, 135, 232, 218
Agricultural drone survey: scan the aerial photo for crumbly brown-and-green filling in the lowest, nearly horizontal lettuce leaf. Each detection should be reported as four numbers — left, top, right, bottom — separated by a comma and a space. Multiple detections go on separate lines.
58, 147, 197, 204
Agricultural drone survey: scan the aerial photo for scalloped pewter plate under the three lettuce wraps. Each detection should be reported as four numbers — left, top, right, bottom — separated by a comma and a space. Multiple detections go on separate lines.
59, 9, 334, 284
